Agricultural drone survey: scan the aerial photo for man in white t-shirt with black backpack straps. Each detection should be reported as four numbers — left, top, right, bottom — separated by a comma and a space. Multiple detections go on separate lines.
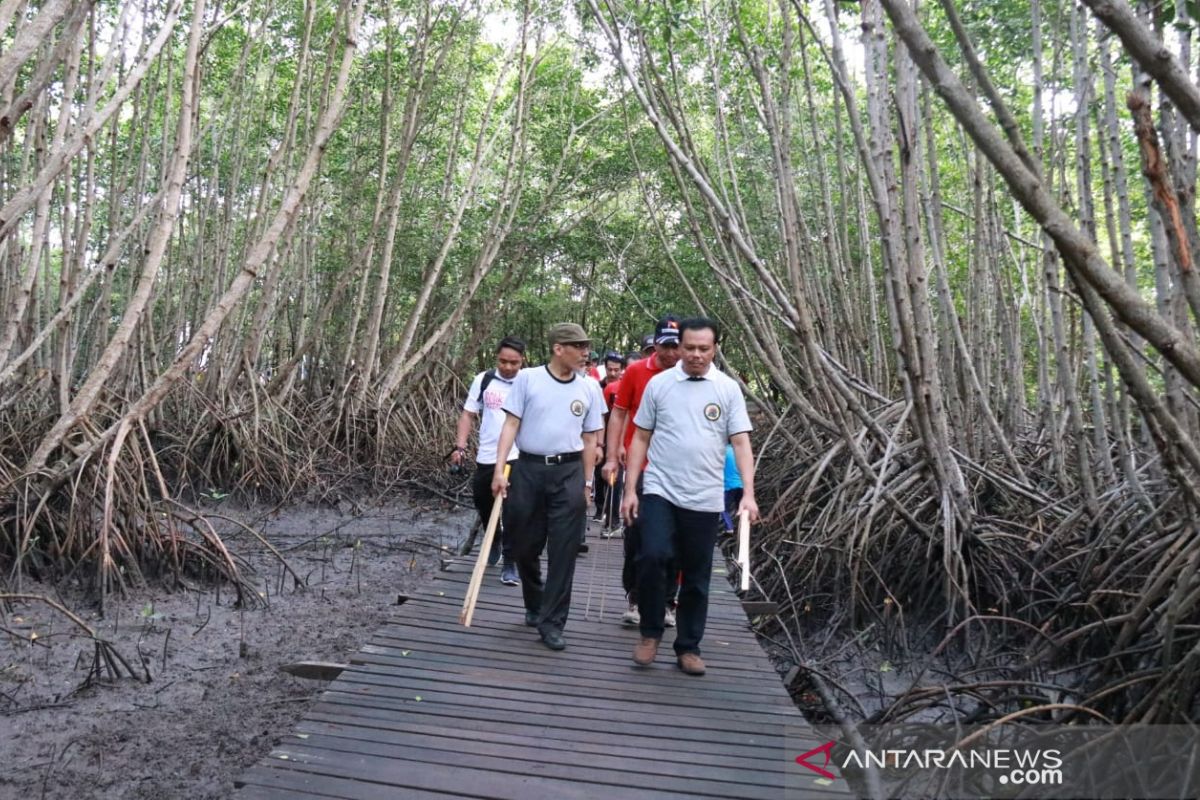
450, 336, 526, 587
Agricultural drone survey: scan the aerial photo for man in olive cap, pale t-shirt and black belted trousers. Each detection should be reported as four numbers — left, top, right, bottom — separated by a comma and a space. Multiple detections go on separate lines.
492, 323, 604, 650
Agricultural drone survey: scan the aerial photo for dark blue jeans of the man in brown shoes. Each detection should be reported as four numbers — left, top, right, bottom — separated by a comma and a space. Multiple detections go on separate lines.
637, 494, 721, 655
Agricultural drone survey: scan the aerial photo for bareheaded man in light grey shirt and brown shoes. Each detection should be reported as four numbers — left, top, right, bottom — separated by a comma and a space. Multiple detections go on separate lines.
620, 318, 758, 675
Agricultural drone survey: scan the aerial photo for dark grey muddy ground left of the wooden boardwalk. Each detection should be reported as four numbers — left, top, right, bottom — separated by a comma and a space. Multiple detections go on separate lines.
0, 500, 470, 800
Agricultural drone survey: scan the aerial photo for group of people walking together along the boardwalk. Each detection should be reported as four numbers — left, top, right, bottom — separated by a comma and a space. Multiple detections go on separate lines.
451, 315, 758, 675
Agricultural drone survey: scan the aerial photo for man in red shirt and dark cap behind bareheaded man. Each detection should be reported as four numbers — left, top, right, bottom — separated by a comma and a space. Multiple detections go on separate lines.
601, 314, 679, 627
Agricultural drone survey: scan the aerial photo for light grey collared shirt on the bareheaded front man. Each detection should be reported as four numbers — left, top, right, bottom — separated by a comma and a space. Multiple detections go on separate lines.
634, 362, 752, 511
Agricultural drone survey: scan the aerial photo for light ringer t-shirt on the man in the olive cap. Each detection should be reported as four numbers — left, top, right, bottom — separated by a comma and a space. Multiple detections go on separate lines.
503, 366, 604, 456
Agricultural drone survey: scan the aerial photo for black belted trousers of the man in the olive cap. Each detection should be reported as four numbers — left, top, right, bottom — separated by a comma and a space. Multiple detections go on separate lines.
504, 461, 588, 633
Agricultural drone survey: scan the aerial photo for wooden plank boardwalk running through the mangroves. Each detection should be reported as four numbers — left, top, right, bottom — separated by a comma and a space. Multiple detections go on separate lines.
229, 533, 845, 800
